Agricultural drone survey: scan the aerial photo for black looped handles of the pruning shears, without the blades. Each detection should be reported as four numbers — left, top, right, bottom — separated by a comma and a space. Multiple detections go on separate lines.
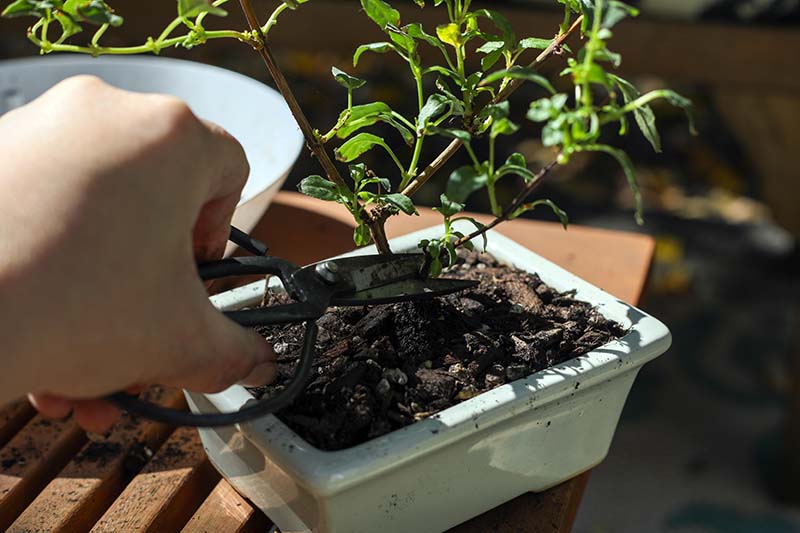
107, 228, 322, 428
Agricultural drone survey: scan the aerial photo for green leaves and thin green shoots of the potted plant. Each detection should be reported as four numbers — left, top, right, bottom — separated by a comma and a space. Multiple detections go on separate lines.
3, 0, 693, 262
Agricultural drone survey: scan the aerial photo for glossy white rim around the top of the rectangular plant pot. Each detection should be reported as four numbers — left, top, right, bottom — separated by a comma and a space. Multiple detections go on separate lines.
198, 221, 671, 496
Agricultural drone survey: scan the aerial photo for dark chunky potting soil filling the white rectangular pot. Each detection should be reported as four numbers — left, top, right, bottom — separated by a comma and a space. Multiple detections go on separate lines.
252, 253, 625, 450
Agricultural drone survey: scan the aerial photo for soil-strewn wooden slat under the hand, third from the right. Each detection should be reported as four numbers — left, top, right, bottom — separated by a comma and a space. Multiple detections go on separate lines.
9, 387, 186, 532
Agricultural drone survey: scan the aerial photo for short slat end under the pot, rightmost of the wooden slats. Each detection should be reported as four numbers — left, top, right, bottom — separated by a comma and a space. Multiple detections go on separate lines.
183, 479, 270, 533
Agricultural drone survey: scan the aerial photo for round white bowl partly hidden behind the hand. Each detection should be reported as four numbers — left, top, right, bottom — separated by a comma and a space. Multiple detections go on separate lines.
0, 55, 303, 236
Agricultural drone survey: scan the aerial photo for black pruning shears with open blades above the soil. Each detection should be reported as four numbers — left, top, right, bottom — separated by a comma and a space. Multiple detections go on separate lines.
108, 228, 477, 427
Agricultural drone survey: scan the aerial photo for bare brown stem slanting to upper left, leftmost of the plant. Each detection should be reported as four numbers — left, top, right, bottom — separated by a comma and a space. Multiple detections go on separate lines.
239, 0, 347, 188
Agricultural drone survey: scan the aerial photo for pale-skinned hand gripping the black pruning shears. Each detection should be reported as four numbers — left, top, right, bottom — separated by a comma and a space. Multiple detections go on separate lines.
0, 77, 275, 432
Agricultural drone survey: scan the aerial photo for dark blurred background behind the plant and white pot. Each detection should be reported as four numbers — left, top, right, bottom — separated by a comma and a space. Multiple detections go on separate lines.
0, 0, 800, 533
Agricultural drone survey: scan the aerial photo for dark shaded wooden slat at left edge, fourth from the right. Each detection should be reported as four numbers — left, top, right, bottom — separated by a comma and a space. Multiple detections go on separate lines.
0, 416, 86, 531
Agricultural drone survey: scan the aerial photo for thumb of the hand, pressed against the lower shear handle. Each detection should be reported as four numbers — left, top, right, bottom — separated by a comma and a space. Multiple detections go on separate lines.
169, 300, 277, 393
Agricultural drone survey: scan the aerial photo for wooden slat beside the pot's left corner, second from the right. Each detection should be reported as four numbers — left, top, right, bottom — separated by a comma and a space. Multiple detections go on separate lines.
92, 428, 219, 532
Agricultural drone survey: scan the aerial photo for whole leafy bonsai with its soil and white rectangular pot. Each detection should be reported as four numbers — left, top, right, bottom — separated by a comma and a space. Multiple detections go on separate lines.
4, 0, 692, 531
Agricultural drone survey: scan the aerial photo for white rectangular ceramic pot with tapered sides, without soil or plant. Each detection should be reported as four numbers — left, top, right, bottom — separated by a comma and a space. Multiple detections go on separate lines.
189, 221, 671, 533
